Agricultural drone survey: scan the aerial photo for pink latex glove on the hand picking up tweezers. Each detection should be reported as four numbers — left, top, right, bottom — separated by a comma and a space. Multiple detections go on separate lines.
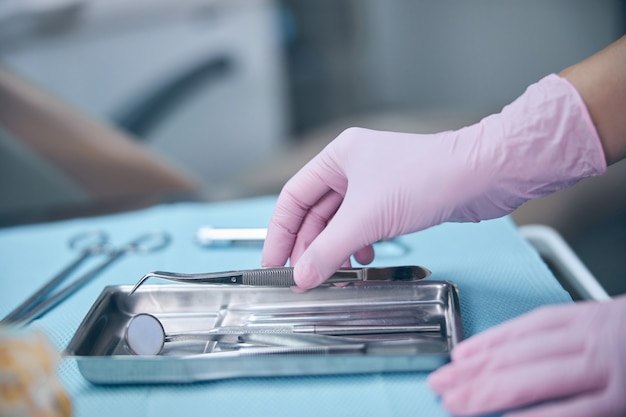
262, 74, 606, 289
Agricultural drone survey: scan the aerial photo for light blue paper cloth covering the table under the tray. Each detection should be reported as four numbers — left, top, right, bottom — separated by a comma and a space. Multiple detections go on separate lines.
0, 197, 571, 417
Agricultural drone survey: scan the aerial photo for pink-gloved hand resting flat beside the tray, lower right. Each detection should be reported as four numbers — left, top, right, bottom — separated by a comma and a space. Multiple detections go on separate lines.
428, 297, 626, 417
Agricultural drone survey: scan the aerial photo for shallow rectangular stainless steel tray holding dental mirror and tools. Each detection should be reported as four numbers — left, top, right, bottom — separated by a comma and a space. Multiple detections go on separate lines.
64, 280, 463, 384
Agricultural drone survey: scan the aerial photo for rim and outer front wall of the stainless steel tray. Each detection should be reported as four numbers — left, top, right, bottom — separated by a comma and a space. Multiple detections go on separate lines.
63, 280, 463, 384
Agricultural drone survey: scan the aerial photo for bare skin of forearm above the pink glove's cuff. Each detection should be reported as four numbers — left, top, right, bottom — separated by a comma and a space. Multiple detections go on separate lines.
560, 36, 626, 164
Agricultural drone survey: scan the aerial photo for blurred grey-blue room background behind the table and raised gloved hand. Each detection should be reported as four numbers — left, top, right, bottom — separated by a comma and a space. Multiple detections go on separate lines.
0, 0, 626, 294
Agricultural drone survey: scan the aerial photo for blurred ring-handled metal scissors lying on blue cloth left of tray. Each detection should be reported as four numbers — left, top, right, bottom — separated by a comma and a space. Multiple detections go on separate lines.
0, 230, 171, 325
